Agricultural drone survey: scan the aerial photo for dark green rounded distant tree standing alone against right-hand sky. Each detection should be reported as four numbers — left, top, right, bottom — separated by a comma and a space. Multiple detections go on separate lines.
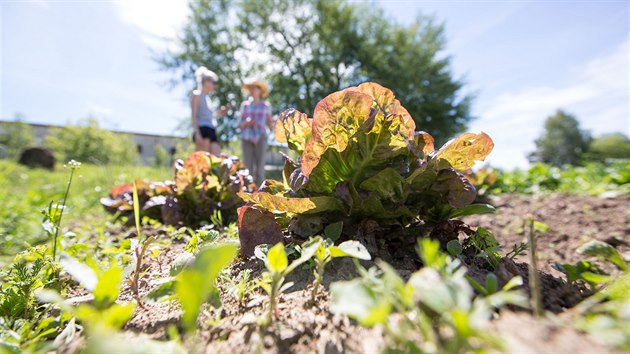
529, 110, 590, 166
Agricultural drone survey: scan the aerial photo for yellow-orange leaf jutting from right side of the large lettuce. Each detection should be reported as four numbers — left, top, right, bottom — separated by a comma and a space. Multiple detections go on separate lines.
432, 132, 494, 171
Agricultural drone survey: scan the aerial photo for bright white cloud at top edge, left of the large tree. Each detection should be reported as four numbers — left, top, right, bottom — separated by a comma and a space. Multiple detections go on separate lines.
115, 0, 188, 48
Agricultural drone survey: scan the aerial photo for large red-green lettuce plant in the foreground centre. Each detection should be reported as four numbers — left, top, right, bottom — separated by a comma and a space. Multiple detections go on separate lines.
239, 82, 494, 254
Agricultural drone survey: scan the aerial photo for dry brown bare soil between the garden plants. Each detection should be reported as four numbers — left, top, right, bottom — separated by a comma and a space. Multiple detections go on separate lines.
73, 195, 630, 353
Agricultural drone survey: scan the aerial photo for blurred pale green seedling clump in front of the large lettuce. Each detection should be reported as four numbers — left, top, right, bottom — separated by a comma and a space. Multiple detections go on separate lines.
330, 239, 527, 353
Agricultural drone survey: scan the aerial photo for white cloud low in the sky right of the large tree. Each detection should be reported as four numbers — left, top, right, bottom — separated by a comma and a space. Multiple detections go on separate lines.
472, 41, 630, 168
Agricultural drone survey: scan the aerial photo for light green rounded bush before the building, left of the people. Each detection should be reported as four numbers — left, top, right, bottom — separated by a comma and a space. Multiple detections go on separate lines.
44, 118, 138, 164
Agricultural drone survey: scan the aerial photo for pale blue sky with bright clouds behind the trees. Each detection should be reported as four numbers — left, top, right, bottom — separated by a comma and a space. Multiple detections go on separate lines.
0, 0, 630, 168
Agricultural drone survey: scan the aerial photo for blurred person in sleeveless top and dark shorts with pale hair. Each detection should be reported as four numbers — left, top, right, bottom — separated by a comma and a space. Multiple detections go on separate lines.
191, 66, 228, 155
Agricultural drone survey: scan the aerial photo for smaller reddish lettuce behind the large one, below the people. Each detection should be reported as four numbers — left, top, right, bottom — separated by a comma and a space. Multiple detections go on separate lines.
101, 151, 255, 225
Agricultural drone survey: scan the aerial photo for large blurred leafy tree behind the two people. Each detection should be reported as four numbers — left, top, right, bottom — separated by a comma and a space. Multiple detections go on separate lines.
160, 0, 472, 142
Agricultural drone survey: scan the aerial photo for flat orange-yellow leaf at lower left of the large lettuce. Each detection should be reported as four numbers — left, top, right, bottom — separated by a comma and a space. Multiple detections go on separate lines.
239, 192, 341, 214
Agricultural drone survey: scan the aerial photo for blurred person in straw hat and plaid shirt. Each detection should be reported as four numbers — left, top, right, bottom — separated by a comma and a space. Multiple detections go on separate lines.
238, 80, 273, 185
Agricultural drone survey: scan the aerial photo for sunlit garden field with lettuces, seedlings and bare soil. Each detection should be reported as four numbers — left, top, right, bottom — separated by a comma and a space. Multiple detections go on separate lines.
0, 83, 630, 353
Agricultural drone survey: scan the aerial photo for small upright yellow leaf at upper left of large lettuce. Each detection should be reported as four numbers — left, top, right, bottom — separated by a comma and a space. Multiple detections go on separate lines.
274, 108, 312, 155
